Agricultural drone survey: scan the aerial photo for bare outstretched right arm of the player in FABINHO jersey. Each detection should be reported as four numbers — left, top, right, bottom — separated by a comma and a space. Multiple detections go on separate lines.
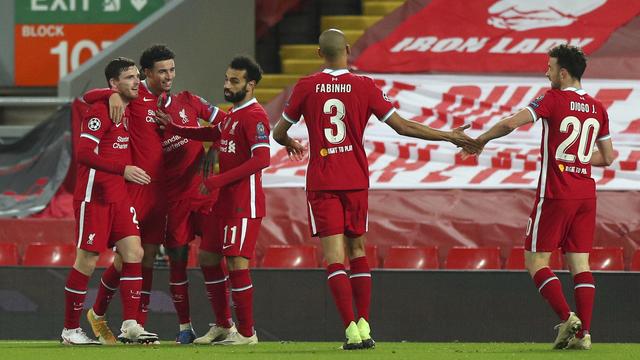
386, 112, 482, 153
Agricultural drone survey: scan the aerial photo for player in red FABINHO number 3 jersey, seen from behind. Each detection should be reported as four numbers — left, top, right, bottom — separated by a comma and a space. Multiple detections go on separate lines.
273, 29, 476, 350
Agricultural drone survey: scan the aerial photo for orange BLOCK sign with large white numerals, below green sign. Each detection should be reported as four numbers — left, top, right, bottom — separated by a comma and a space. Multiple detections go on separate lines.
15, 24, 135, 86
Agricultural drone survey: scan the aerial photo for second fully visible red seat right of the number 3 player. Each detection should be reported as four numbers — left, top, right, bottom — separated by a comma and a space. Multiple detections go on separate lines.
446, 247, 501, 270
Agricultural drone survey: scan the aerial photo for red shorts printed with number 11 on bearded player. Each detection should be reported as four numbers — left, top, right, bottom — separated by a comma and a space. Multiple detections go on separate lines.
200, 215, 262, 259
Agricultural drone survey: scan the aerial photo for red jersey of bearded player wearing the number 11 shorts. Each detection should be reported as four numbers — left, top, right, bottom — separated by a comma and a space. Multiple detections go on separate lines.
213, 99, 269, 219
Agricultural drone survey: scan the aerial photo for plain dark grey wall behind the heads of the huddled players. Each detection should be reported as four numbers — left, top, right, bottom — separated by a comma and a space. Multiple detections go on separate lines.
58, 0, 255, 103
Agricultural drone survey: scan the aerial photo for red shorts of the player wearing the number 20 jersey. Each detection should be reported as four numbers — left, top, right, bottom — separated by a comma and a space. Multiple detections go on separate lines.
524, 198, 596, 253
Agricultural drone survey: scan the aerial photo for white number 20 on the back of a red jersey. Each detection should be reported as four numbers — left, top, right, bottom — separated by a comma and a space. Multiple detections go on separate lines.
556, 116, 600, 164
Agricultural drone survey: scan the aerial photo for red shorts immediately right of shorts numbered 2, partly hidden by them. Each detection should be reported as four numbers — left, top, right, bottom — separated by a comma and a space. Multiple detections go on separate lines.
127, 181, 167, 245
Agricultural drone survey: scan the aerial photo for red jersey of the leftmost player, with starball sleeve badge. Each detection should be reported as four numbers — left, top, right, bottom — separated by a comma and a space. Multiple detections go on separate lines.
73, 102, 131, 202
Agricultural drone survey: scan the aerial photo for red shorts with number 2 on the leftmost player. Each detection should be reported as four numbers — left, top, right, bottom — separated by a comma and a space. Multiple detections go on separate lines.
73, 199, 140, 253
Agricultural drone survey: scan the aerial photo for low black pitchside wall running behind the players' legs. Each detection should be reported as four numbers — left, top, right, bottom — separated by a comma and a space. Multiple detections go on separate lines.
0, 267, 640, 343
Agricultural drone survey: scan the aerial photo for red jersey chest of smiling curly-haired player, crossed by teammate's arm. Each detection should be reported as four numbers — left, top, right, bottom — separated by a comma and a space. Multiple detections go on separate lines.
162, 91, 226, 201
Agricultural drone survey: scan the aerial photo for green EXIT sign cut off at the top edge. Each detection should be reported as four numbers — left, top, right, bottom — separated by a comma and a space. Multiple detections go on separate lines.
15, 0, 165, 24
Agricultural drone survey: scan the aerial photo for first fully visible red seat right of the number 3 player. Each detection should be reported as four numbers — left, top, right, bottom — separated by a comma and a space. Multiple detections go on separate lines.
384, 246, 439, 270
